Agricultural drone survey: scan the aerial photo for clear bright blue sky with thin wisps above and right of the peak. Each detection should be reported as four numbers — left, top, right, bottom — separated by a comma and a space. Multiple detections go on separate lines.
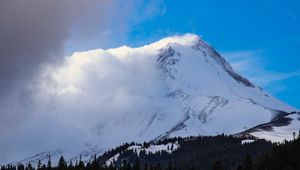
67, 0, 300, 108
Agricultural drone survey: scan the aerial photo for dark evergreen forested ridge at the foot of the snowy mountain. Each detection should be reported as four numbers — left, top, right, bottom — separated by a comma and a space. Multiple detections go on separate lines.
1, 132, 300, 170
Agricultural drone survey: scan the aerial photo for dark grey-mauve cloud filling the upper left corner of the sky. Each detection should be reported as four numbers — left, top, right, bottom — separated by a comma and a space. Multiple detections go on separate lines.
0, 0, 115, 131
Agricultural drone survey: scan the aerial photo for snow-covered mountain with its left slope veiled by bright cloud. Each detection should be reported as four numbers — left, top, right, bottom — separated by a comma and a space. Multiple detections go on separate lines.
4, 34, 300, 164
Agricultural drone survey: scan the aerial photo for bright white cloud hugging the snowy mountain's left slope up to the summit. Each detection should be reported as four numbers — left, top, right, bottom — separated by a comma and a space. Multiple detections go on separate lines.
0, 35, 191, 161
